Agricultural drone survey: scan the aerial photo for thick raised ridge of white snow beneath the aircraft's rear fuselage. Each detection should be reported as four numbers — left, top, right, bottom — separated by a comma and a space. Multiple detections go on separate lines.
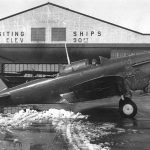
0, 109, 87, 129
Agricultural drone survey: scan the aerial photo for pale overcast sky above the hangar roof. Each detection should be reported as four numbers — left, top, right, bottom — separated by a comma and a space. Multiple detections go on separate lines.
0, 0, 150, 33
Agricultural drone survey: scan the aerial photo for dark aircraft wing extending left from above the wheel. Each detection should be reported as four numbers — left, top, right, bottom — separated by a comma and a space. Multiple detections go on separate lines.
61, 76, 126, 102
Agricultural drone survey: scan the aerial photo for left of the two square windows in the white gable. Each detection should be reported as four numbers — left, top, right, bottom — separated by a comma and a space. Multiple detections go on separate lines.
31, 28, 45, 42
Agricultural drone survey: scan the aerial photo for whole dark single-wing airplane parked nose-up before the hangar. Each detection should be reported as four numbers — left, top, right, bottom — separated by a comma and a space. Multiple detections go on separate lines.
0, 53, 150, 117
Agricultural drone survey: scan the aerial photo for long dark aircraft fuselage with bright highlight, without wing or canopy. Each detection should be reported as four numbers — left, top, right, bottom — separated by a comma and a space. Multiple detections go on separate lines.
0, 54, 150, 105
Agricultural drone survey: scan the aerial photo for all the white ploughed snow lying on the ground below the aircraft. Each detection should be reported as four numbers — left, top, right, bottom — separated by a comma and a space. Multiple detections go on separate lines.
0, 109, 125, 150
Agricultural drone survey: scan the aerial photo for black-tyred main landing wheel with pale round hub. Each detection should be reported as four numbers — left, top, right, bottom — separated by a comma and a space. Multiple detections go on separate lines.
119, 97, 137, 118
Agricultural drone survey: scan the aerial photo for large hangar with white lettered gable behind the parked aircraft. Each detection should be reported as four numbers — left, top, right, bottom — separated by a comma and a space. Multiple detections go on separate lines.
0, 3, 150, 76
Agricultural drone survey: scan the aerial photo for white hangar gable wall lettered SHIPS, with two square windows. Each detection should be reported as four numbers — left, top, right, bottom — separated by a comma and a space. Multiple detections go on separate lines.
0, 3, 150, 43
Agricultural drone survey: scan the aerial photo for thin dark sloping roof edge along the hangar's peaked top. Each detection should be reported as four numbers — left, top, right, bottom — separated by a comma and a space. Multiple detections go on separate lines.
0, 2, 150, 35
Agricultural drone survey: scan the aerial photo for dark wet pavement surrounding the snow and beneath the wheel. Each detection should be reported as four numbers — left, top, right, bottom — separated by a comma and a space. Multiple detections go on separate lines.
0, 95, 150, 150
